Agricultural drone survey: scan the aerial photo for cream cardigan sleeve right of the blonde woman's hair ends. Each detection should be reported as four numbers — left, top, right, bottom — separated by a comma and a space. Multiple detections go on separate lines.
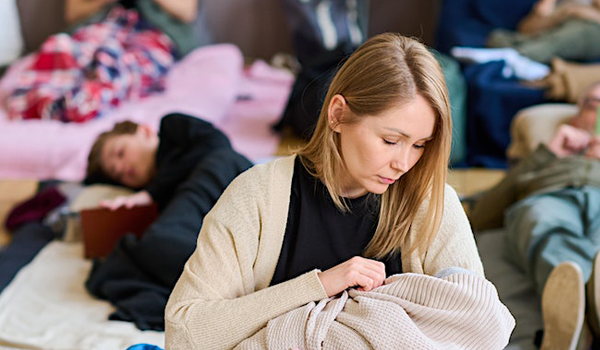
407, 185, 484, 277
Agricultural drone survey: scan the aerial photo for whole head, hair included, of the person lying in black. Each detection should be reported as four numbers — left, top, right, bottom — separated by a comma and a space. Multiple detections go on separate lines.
86, 121, 158, 189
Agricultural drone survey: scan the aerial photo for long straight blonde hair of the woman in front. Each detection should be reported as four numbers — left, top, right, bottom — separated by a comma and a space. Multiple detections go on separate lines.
298, 33, 452, 258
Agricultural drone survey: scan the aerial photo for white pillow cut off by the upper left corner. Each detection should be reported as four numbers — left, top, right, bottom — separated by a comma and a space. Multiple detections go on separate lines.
0, 0, 23, 66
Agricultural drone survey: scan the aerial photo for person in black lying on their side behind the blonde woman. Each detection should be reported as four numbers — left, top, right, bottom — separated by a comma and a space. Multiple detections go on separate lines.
86, 114, 251, 330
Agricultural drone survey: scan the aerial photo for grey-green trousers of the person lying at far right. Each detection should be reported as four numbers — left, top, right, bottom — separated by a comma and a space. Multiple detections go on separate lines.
505, 189, 597, 293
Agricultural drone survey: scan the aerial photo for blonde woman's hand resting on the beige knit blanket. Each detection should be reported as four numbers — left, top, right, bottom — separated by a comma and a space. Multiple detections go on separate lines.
319, 256, 385, 296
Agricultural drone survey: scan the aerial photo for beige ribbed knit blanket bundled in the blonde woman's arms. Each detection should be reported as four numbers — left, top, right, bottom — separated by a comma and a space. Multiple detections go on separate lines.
236, 273, 515, 350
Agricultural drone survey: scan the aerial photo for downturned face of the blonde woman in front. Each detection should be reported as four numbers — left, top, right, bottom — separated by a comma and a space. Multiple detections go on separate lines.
330, 95, 435, 198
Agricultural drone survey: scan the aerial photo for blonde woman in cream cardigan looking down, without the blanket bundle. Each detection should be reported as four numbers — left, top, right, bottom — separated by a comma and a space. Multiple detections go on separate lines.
165, 33, 483, 349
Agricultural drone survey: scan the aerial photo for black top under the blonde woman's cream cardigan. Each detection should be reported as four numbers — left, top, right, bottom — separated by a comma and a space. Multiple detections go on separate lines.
271, 157, 402, 285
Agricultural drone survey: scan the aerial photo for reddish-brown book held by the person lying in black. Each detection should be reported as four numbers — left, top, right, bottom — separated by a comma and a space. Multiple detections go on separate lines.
79, 204, 158, 258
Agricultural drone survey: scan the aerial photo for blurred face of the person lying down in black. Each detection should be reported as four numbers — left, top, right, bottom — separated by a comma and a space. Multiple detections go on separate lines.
101, 125, 158, 188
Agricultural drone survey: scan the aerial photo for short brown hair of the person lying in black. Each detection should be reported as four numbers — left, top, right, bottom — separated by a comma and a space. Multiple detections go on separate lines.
84, 120, 139, 184
